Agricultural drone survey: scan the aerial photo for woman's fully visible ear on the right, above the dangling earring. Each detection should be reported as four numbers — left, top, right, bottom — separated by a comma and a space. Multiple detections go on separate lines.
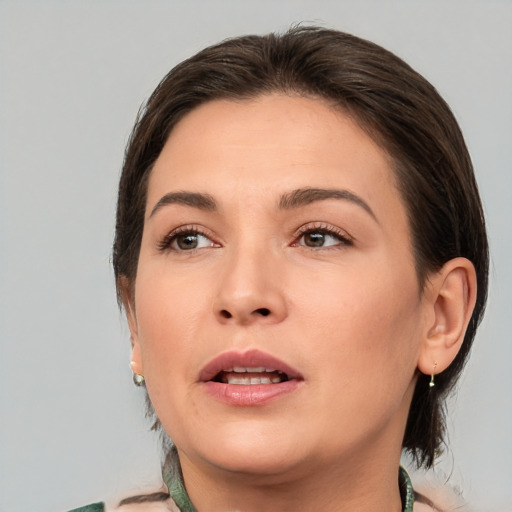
418, 258, 476, 375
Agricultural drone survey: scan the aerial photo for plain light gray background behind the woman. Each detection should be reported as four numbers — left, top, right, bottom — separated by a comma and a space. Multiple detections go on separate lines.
0, 0, 512, 512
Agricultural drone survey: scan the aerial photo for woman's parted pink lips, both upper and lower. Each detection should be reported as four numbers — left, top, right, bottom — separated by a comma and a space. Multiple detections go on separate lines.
199, 349, 304, 406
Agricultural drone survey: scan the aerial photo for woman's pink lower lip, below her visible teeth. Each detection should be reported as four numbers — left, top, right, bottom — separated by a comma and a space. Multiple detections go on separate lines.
204, 379, 303, 407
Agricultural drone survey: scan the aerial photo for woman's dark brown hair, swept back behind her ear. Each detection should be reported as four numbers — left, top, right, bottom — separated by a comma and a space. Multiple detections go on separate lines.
113, 27, 488, 467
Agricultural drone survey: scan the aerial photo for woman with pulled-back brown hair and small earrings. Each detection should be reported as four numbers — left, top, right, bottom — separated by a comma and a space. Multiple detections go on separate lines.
71, 27, 488, 512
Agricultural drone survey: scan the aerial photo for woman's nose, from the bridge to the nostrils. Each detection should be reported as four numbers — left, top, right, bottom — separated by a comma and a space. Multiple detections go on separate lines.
213, 246, 288, 325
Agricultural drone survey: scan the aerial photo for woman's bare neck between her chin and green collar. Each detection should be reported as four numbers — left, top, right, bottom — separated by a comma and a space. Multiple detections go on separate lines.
176, 450, 402, 512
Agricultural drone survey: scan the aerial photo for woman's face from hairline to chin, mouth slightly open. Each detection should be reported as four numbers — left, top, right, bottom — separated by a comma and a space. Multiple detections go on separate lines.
128, 94, 428, 480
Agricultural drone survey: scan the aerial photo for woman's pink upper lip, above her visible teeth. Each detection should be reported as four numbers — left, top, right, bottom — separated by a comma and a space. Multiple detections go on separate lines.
199, 349, 303, 382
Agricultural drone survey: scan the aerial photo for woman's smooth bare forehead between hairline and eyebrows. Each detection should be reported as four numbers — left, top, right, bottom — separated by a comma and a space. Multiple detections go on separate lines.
148, 94, 401, 220
